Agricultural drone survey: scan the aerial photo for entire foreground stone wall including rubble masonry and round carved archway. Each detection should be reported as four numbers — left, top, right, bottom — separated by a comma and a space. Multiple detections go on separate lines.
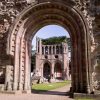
0, 0, 100, 93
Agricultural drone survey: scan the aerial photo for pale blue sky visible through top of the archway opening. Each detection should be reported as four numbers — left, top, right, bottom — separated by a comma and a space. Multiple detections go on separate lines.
32, 25, 70, 50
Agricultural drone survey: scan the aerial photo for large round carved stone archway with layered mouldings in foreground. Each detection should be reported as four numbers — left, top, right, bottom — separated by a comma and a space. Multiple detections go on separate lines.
1, 2, 91, 93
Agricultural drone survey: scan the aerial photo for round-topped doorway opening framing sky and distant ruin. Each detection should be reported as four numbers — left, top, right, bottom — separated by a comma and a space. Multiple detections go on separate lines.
31, 25, 71, 95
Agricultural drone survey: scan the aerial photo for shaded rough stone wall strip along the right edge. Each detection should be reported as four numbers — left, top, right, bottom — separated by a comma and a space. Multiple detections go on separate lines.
90, 0, 100, 91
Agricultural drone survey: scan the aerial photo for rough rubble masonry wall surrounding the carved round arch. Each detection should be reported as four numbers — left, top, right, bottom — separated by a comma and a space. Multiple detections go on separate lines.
0, 0, 100, 93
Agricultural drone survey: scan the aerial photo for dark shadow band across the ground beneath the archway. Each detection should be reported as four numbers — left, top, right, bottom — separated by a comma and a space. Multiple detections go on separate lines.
31, 89, 73, 98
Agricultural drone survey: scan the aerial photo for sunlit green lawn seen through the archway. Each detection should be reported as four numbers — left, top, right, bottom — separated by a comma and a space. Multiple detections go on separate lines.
32, 81, 71, 91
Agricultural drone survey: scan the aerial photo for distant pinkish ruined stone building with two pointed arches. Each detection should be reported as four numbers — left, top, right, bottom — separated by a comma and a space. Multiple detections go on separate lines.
36, 37, 69, 79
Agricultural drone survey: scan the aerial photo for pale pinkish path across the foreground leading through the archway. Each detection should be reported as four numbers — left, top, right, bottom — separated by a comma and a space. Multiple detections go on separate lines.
0, 86, 73, 100
